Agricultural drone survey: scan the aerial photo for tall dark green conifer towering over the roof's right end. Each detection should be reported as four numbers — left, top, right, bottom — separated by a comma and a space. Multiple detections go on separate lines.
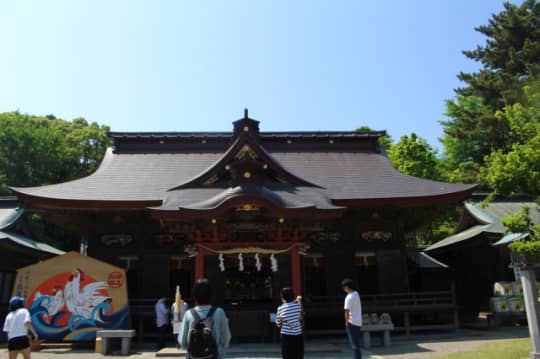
441, 0, 540, 180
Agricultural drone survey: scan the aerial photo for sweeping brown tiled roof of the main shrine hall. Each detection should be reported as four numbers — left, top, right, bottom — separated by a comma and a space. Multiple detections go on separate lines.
13, 115, 475, 208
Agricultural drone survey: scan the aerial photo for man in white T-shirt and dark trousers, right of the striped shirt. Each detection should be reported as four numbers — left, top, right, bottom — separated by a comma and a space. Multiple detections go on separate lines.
341, 278, 362, 359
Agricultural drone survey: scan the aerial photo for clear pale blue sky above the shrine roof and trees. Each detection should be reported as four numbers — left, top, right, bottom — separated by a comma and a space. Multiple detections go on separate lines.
0, 0, 503, 148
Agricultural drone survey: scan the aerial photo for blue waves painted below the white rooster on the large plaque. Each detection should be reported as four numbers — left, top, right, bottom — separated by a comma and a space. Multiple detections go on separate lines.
29, 296, 128, 341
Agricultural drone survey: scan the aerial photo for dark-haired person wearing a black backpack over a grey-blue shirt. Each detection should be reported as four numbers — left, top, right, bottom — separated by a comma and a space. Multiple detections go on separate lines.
178, 278, 231, 359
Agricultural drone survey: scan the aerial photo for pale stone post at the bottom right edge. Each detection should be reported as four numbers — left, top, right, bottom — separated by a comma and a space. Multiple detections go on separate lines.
521, 269, 540, 359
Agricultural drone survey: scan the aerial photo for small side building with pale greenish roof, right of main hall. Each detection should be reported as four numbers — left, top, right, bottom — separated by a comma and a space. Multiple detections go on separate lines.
425, 195, 540, 320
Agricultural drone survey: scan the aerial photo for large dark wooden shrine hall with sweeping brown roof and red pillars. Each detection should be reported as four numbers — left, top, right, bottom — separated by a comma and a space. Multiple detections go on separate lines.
12, 110, 475, 337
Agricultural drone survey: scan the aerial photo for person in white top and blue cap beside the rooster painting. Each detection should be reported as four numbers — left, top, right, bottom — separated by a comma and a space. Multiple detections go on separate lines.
4, 297, 38, 359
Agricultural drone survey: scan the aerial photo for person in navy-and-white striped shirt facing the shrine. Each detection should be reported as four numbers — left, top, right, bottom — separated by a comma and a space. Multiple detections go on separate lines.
276, 287, 304, 359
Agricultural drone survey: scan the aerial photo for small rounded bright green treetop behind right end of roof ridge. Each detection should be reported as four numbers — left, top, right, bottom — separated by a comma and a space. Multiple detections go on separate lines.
388, 133, 441, 180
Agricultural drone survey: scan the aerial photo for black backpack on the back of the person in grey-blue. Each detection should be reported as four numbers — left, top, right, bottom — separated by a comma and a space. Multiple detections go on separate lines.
187, 307, 218, 359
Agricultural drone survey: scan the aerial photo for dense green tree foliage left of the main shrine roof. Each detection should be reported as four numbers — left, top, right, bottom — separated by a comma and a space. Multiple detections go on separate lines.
0, 112, 110, 194
